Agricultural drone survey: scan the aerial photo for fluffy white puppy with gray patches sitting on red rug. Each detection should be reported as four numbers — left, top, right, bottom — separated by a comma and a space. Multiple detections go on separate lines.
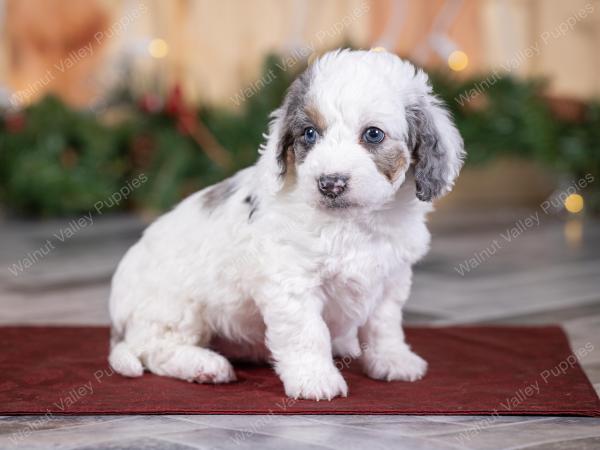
109, 50, 464, 400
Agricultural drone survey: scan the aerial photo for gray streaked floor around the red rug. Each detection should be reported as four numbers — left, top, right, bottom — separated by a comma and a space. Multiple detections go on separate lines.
0, 211, 600, 450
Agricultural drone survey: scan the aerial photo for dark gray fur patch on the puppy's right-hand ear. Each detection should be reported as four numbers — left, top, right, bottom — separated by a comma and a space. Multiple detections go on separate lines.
406, 104, 448, 202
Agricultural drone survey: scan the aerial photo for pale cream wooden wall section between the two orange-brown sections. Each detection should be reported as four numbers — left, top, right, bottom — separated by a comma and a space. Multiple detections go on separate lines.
149, 0, 370, 106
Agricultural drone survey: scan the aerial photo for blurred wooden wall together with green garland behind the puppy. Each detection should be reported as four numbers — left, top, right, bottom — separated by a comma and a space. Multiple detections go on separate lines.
0, 0, 600, 218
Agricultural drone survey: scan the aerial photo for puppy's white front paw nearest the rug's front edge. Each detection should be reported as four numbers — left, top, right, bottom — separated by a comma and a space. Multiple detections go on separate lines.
281, 364, 348, 401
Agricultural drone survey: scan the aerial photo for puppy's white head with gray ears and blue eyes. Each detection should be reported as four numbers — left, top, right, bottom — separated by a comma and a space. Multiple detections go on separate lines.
263, 50, 464, 209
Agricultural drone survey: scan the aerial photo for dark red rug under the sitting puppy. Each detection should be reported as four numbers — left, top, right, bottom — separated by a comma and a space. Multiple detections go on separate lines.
0, 327, 600, 416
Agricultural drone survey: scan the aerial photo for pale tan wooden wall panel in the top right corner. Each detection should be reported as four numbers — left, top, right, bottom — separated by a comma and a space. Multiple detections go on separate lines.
482, 0, 600, 98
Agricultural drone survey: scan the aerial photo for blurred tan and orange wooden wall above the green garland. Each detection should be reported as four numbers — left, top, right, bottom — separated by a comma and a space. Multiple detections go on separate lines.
0, 0, 600, 108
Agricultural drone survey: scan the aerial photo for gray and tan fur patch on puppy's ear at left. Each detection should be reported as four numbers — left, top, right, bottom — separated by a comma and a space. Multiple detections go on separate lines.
277, 67, 323, 176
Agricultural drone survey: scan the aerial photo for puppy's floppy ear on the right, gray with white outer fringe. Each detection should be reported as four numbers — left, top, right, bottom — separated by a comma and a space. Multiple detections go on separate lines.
406, 94, 465, 202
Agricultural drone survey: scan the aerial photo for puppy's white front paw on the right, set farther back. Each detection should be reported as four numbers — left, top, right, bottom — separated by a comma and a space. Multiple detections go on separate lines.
363, 347, 427, 381
